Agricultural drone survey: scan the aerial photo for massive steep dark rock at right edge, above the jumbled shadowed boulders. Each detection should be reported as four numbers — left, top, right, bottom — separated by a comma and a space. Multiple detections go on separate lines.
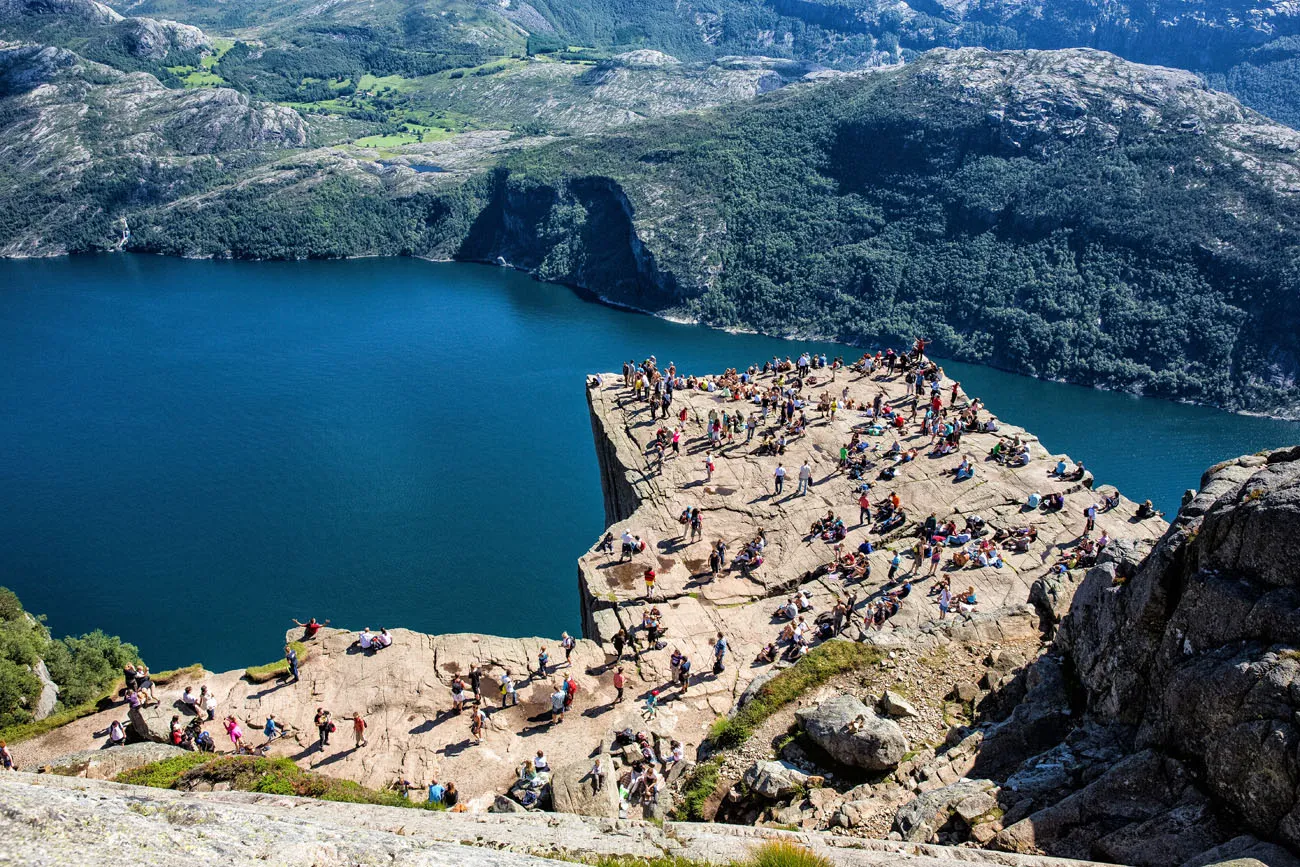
1057, 447, 1300, 849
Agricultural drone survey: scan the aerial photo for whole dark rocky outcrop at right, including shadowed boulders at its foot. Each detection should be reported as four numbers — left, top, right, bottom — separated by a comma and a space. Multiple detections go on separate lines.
951, 447, 1300, 867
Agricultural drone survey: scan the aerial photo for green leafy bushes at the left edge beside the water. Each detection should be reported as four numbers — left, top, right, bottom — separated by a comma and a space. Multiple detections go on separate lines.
0, 588, 139, 729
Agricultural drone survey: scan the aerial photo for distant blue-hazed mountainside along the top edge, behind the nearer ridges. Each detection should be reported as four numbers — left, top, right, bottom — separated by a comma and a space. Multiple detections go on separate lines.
71, 0, 1300, 125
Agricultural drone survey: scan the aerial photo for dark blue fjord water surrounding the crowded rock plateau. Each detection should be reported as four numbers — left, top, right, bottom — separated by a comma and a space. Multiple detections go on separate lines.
0, 256, 1300, 669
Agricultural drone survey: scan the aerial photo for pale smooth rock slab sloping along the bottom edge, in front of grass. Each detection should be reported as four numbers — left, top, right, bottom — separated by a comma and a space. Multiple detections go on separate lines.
0, 773, 1112, 867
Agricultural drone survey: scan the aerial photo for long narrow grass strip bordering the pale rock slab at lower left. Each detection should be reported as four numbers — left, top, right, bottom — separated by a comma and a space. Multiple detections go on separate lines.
117, 753, 446, 810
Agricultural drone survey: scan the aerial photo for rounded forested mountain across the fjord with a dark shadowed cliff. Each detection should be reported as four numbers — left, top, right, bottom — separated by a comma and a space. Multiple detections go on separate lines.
73, 49, 1300, 412
